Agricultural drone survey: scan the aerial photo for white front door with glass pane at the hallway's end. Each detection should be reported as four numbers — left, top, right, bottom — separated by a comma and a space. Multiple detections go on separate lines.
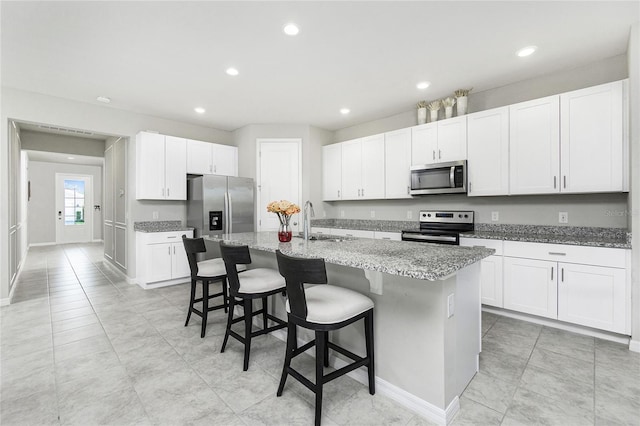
55, 173, 93, 244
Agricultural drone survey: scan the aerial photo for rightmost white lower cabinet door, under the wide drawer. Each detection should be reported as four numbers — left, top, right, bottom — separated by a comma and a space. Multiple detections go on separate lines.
558, 263, 630, 334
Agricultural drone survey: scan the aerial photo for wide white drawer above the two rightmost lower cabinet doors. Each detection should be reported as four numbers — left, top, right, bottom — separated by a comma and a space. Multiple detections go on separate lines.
504, 241, 626, 268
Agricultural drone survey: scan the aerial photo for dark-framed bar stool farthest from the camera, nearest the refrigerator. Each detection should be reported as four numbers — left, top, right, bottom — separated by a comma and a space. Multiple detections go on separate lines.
182, 235, 247, 338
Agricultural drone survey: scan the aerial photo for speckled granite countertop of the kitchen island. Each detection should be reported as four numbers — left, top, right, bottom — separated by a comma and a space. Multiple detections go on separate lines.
205, 232, 495, 281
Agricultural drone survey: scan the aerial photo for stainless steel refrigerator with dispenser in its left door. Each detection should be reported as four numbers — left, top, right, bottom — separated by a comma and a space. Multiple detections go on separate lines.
187, 175, 255, 237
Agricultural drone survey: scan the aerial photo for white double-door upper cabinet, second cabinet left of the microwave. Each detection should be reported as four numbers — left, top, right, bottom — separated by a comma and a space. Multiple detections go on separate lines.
341, 134, 385, 200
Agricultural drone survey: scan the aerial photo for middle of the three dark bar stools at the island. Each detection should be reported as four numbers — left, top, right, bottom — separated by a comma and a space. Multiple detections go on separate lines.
220, 242, 287, 371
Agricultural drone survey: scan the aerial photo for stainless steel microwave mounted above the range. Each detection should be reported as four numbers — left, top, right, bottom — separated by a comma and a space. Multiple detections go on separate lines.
411, 160, 467, 195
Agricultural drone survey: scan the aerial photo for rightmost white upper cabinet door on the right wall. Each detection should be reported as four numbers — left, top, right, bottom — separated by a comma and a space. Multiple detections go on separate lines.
560, 81, 625, 192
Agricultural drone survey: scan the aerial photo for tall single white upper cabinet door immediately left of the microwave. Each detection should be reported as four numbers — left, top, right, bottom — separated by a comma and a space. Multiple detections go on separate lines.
384, 129, 411, 198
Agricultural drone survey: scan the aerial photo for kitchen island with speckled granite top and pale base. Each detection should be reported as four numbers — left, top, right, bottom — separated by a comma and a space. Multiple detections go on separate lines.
205, 232, 493, 424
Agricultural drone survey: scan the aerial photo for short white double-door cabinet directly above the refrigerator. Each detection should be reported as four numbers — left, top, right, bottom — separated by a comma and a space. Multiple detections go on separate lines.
187, 139, 238, 176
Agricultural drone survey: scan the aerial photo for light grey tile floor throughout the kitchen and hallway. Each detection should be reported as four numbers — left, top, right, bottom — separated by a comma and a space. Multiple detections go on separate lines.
0, 244, 640, 426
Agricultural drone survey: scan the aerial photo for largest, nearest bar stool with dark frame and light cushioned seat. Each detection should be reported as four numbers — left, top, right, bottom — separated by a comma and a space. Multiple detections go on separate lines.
276, 250, 375, 425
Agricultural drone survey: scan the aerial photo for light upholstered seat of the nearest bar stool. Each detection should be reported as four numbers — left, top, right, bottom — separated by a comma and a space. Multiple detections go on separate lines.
286, 285, 373, 324
